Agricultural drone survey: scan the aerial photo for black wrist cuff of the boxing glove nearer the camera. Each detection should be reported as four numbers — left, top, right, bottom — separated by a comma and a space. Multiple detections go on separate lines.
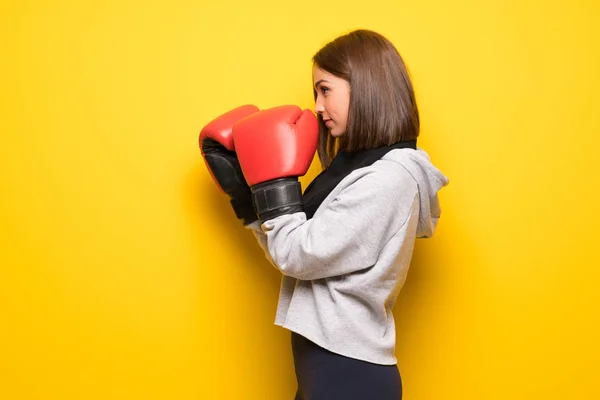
252, 178, 304, 223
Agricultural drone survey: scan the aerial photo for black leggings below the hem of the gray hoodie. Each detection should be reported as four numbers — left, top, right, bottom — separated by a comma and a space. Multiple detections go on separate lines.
292, 332, 402, 400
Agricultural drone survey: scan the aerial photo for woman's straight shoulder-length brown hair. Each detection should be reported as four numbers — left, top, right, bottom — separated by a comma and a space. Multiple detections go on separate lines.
313, 29, 419, 168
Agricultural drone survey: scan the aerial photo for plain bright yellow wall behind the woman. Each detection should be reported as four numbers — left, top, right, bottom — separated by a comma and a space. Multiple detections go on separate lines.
0, 0, 600, 400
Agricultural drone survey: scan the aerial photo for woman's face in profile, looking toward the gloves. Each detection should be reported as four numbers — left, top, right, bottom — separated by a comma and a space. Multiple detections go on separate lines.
313, 64, 350, 137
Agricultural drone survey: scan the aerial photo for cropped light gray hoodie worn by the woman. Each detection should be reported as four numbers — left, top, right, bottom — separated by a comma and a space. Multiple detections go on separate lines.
247, 148, 449, 365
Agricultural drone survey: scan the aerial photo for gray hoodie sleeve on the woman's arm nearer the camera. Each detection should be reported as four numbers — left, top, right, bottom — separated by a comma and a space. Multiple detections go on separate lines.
255, 168, 418, 280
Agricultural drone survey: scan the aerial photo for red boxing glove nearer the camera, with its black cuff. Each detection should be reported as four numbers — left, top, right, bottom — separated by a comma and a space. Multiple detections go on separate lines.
233, 105, 319, 222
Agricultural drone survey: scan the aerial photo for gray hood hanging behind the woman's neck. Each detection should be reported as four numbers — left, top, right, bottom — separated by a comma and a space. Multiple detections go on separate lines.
383, 147, 450, 238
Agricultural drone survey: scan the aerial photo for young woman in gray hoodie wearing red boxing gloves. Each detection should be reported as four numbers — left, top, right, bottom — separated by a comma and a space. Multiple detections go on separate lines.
201, 30, 449, 400
